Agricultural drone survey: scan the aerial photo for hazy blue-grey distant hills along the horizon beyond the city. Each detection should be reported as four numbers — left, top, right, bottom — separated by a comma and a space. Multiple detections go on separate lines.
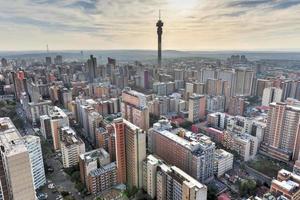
0, 50, 300, 61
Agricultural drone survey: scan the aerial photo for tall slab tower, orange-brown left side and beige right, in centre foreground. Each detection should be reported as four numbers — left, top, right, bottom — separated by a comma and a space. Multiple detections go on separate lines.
113, 118, 146, 188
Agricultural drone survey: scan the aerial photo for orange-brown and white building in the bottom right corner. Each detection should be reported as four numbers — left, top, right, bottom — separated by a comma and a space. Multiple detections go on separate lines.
270, 169, 300, 200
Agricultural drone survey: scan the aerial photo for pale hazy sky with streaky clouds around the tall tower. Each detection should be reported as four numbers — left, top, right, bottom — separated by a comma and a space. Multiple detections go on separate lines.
0, 0, 300, 50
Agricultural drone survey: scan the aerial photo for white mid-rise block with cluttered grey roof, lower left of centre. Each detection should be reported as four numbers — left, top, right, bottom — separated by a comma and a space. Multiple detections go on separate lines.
60, 126, 85, 168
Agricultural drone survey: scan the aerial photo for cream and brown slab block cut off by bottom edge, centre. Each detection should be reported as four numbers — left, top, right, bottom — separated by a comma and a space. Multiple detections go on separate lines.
143, 155, 207, 200
